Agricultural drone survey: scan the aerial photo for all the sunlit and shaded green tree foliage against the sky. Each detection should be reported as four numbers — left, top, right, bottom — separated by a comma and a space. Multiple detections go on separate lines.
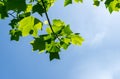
0, 0, 120, 60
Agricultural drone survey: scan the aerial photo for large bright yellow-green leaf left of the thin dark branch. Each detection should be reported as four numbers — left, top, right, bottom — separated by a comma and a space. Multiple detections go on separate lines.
18, 16, 42, 37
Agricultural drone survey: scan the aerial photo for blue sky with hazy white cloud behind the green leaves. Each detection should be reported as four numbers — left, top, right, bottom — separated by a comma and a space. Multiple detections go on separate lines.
0, 0, 120, 79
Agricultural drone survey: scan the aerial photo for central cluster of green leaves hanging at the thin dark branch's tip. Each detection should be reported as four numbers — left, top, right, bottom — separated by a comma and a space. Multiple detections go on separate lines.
31, 19, 84, 60
